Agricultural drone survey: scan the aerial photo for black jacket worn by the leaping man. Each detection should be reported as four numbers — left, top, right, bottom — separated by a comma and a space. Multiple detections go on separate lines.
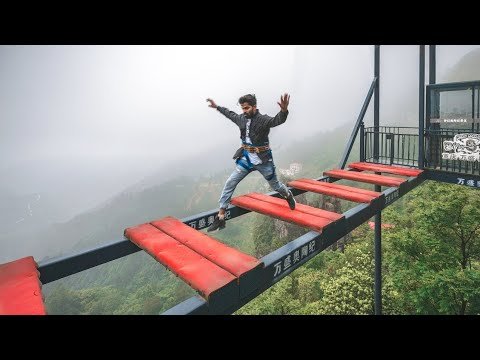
217, 106, 288, 163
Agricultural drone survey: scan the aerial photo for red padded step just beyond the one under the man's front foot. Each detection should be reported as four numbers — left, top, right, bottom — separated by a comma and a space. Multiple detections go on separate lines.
288, 179, 382, 203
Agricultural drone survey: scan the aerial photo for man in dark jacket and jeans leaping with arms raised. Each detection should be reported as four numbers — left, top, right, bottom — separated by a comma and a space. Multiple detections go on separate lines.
207, 94, 295, 231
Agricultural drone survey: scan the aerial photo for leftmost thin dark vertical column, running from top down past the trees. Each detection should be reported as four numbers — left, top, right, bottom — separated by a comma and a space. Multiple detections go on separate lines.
373, 45, 382, 315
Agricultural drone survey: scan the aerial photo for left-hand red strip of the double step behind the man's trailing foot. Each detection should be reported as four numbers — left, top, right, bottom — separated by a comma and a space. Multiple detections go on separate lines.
124, 224, 236, 300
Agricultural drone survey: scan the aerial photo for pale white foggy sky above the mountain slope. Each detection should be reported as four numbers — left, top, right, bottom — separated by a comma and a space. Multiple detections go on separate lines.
0, 45, 478, 262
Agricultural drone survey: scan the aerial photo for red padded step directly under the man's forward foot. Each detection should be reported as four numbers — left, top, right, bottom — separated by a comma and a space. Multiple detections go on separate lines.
231, 193, 343, 232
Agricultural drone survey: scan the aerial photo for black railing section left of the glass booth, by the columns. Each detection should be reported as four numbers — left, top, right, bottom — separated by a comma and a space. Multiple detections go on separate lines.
361, 126, 418, 166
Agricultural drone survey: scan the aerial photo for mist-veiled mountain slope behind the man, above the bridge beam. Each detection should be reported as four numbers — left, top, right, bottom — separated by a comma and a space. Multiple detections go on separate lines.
2, 119, 357, 266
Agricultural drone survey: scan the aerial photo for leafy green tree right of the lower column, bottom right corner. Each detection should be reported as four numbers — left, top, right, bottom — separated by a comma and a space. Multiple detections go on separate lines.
385, 182, 480, 315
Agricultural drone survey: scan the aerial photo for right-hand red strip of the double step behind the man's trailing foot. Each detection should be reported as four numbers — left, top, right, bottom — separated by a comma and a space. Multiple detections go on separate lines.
150, 216, 263, 278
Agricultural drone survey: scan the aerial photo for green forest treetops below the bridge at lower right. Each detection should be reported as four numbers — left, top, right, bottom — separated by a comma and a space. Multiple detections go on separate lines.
237, 182, 480, 315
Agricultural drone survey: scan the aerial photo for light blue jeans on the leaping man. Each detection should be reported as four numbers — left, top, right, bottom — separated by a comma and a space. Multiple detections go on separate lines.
218, 161, 288, 209
